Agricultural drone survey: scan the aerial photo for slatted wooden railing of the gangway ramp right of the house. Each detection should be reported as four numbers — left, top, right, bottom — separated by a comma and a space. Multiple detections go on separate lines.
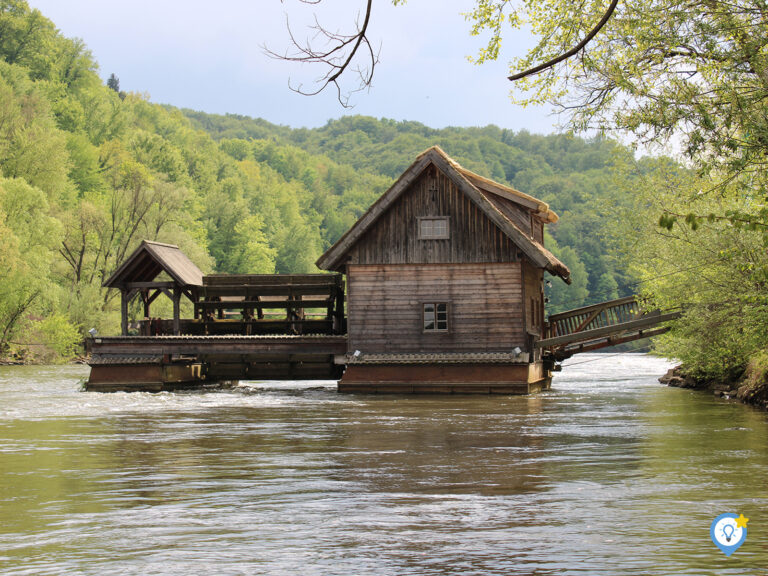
545, 296, 641, 338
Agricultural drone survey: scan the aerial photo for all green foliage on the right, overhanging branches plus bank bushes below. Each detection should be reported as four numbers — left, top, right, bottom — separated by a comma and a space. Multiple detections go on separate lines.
460, 0, 768, 378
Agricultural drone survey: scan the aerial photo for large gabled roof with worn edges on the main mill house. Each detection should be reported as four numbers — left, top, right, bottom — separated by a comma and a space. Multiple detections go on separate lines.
317, 146, 571, 284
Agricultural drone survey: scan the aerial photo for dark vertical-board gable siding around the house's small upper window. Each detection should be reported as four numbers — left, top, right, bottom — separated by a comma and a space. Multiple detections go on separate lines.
349, 166, 530, 264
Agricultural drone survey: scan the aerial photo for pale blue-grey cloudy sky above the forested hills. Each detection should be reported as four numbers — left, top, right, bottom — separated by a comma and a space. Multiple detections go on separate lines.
28, 0, 557, 134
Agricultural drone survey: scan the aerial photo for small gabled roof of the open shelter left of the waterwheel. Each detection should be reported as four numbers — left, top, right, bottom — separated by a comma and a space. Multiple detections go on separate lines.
104, 240, 203, 288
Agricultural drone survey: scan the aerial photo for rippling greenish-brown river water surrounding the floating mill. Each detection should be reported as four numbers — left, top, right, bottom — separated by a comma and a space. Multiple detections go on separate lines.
0, 354, 768, 576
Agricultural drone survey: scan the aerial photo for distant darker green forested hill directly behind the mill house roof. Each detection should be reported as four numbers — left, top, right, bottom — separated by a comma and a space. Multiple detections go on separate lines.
183, 110, 635, 311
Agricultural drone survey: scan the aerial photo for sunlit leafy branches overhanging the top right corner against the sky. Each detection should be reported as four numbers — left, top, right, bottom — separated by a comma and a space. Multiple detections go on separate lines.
471, 0, 768, 202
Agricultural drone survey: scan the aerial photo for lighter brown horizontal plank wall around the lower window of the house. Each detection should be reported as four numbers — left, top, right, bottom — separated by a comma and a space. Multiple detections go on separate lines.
347, 263, 528, 354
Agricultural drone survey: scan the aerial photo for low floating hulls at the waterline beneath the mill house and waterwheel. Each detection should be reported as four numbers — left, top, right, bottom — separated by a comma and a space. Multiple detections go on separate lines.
85, 335, 551, 394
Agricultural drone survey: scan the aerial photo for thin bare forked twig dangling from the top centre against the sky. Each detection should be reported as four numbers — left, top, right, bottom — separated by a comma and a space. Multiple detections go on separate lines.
262, 0, 379, 108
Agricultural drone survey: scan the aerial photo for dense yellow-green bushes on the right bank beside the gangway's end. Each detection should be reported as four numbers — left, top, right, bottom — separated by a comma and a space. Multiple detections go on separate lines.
615, 160, 768, 379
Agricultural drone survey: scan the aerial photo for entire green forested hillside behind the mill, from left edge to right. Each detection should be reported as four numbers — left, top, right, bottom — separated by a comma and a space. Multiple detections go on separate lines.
0, 0, 632, 356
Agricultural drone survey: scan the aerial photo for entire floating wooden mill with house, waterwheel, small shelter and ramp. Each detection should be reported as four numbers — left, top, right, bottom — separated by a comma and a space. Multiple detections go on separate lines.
87, 147, 677, 394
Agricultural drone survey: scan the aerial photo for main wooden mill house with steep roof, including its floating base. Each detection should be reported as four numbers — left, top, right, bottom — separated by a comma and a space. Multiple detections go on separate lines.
317, 147, 570, 393
